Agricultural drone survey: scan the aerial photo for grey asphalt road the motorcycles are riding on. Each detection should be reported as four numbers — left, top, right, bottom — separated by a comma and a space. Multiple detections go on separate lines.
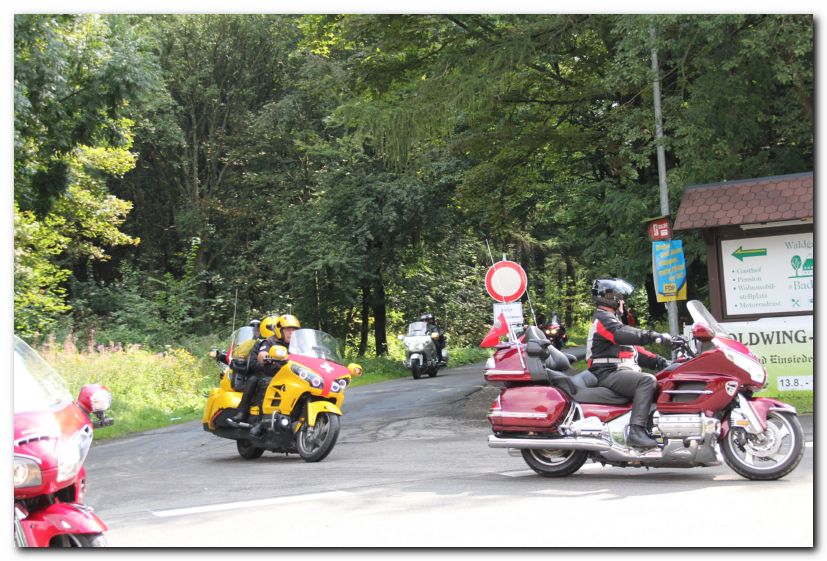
87, 365, 814, 548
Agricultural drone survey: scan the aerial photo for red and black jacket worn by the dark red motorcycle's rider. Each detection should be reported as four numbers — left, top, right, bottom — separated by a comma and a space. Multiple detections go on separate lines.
586, 308, 666, 378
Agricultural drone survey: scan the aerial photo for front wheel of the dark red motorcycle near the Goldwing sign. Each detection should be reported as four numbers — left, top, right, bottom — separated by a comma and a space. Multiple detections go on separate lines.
721, 411, 804, 481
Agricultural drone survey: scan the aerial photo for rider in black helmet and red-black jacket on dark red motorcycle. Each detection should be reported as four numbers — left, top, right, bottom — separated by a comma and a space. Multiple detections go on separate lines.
586, 278, 672, 448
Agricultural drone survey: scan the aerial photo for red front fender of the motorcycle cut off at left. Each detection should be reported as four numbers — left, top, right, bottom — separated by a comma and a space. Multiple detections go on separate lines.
21, 503, 108, 547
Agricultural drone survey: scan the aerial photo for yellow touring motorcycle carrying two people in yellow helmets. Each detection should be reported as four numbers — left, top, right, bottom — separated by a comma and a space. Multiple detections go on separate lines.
202, 326, 362, 462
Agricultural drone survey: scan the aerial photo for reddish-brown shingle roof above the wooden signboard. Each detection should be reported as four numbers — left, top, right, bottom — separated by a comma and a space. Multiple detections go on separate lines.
673, 172, 814, 230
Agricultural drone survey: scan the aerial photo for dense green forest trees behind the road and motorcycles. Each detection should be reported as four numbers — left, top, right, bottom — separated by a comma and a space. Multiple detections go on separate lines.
14, 14, 814, 354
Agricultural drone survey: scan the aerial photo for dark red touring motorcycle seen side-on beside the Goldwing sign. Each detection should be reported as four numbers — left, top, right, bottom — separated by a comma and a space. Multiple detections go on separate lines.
485, 300, 804, 480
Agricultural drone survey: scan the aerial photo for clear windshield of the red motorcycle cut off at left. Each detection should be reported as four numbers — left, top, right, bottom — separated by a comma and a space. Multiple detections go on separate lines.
14, 335, 72, 413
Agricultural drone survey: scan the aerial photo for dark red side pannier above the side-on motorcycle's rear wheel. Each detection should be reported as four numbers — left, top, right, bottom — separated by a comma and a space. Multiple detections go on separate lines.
488, 386, 571, 432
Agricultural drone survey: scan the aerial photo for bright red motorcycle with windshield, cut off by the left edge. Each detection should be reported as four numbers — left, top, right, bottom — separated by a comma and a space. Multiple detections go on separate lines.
14, 336, 113, 547
